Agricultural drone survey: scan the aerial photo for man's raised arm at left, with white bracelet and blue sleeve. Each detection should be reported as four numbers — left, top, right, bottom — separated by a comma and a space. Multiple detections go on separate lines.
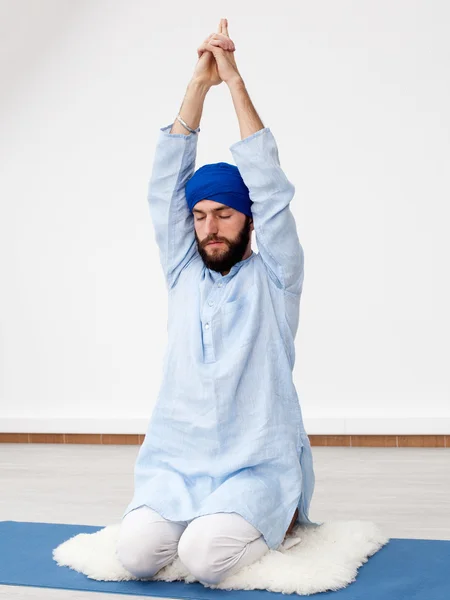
147, 22, 234, 290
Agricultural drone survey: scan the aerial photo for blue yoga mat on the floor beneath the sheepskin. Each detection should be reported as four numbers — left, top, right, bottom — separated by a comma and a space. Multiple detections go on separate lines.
0, 521, 450, 600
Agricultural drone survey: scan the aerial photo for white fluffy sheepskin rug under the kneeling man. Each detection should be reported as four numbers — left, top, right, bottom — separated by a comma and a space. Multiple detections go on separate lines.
53, 521, 389, 595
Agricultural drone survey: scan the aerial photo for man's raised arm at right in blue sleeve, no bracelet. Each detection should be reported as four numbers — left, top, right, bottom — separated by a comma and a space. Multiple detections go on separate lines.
205, 23, 303, 294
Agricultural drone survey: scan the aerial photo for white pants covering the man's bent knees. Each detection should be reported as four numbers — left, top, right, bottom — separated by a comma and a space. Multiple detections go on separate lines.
117, 506, 269, 585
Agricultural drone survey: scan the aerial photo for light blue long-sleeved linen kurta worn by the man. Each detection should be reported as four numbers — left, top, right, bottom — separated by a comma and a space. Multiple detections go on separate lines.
123, 124, 317, 549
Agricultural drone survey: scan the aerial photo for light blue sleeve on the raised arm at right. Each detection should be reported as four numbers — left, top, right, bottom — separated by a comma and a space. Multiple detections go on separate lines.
230, 127, 304, 294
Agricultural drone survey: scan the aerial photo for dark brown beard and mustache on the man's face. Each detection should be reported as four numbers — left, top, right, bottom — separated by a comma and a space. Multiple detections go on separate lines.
195, 215, 251, 273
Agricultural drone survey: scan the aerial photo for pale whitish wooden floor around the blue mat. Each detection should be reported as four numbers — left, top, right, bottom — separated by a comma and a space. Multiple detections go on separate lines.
0, 443, 450, 600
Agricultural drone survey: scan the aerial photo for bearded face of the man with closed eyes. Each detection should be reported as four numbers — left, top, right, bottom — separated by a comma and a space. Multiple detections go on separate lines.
192, 200, 253, 274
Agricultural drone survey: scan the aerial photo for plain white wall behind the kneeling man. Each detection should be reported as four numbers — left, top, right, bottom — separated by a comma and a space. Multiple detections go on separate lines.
0, 0, 450, 434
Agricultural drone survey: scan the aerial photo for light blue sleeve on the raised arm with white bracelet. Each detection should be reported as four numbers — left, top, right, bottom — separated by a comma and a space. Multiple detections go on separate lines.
148, 123, 200, 290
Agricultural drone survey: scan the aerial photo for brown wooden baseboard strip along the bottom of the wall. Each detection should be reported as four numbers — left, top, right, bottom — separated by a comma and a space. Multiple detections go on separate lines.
0, 433, 450, 448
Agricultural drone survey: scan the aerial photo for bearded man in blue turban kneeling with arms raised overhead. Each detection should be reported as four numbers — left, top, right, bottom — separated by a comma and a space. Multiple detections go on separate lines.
117, 19, 315, 584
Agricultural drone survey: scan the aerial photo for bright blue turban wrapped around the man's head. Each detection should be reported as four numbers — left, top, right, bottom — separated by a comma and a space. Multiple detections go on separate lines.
185, 162, 252, 217
